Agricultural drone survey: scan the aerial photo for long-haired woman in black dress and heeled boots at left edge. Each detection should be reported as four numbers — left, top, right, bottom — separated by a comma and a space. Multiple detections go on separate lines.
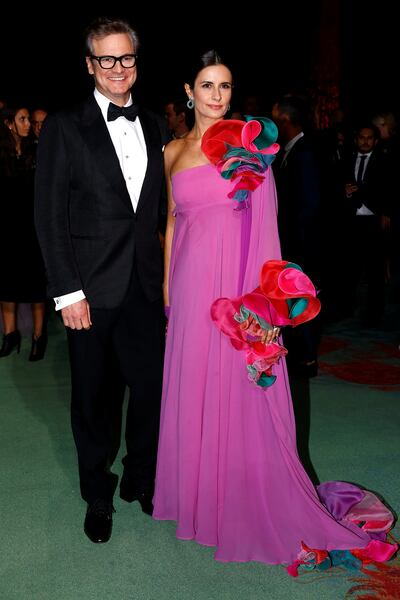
0, 106, 47, 361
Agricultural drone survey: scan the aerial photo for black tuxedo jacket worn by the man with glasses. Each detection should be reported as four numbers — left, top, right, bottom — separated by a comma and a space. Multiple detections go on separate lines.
35, 96, 168, 308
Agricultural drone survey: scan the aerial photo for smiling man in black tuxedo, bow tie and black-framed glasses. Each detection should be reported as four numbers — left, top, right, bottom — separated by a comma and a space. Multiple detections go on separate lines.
35, 18, 167, 542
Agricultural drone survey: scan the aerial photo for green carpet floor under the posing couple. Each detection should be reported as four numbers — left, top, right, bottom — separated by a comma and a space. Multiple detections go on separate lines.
0, 317, 400, 600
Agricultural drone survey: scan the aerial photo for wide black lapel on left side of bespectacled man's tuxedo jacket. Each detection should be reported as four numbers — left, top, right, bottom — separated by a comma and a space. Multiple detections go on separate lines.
78, 97, 132, 210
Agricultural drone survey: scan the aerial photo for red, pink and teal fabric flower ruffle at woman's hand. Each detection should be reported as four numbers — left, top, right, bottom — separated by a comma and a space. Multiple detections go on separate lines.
211, 260, 321, 387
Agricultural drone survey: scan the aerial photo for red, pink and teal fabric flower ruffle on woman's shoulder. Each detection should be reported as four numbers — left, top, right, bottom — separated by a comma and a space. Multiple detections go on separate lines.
201, 115, 279, 208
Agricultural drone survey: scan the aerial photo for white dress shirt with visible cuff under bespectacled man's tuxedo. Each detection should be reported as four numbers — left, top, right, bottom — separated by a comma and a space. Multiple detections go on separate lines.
54, 89, 147, 310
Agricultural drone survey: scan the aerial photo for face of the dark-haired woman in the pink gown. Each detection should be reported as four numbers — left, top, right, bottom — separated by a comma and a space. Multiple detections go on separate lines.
186, 65, 232, 119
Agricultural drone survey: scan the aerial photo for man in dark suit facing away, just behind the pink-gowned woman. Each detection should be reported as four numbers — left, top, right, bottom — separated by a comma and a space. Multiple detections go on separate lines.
272, 96, 321, 377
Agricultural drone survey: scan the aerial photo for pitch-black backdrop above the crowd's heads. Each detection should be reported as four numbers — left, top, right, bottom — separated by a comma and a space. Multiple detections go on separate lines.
0, 0, 399, 119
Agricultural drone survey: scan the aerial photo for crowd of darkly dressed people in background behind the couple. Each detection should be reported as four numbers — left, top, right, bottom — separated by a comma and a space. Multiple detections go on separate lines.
0, 93, 400, 368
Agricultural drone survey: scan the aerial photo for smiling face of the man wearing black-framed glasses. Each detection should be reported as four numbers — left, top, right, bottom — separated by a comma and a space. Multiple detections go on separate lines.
86, 33, 137, 106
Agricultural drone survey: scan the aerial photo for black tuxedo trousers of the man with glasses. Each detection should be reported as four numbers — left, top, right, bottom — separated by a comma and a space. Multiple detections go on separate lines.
67, 274, 164, 503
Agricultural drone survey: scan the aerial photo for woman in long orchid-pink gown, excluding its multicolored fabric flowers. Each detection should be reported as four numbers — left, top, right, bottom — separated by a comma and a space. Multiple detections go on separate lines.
153, 52, 395, 564
